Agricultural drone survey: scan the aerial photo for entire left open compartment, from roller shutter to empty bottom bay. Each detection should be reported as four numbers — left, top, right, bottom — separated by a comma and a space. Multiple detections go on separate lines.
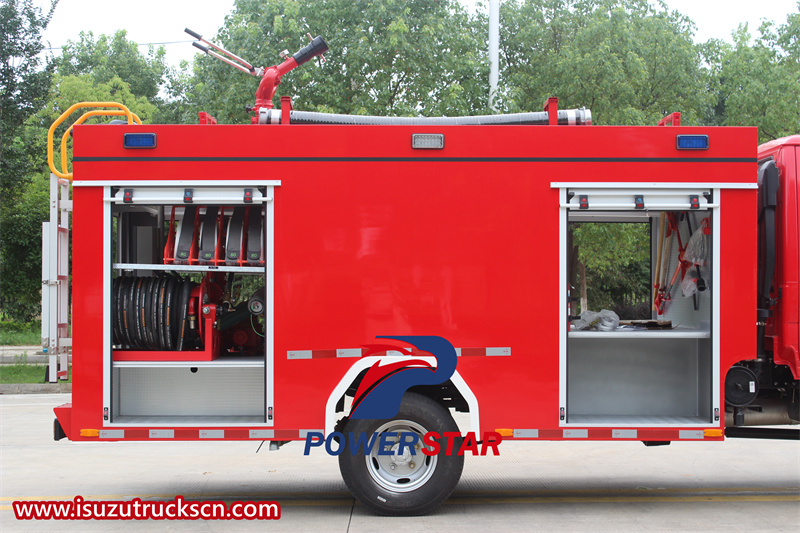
106, 187, 273, 425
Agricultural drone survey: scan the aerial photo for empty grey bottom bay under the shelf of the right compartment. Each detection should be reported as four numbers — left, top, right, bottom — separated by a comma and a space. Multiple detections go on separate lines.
567, 336, 712, 425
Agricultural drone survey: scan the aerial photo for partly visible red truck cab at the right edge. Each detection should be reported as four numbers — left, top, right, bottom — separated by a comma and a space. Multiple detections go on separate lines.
736, 135, 800, 428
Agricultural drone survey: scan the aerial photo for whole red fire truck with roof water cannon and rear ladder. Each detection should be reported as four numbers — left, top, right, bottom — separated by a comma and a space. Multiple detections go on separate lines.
43, 36, 800, 514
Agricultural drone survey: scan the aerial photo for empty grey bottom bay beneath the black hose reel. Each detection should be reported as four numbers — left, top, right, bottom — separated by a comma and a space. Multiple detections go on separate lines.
111, 363, 266, 423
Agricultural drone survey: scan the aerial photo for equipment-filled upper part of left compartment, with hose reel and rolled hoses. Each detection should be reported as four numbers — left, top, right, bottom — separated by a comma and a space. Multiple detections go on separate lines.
110, 195, 266, 361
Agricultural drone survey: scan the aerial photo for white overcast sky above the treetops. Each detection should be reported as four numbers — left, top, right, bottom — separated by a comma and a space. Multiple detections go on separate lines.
34, 0, 798, 65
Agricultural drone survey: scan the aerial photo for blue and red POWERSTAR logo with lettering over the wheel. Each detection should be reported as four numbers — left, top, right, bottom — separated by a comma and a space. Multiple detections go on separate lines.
303, 335, 503, 456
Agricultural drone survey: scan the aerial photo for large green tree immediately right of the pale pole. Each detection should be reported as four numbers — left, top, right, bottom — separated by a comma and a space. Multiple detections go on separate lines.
500, 0, 708, 124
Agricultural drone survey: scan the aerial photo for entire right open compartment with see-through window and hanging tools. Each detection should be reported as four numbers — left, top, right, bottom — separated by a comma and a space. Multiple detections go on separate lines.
561, 185, 719, 427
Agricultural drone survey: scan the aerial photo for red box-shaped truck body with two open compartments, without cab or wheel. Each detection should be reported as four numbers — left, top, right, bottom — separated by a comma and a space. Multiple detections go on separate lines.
50, 117, 768, 440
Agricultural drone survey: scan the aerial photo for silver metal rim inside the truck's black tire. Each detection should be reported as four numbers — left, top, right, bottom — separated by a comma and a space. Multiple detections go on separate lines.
364, 420, 438, 492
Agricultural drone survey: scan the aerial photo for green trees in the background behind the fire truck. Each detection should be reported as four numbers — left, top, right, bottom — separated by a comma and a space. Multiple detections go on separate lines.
0, 0, 800, 320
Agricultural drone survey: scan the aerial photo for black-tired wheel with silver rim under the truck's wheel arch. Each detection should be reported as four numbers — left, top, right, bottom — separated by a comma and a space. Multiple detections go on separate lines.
339, 392, 464, 516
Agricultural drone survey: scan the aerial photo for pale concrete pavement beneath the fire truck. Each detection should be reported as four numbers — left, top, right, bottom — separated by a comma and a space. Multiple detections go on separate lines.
0, 394, 800, 532
